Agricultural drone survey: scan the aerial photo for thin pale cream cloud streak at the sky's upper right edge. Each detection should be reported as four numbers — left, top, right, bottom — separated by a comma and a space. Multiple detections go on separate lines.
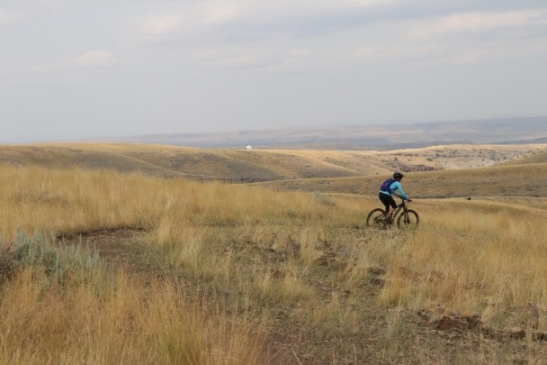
409, 10, 547, 38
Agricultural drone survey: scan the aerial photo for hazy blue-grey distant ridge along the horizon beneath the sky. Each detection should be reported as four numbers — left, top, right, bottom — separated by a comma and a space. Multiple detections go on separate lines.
99, 116, 547, 149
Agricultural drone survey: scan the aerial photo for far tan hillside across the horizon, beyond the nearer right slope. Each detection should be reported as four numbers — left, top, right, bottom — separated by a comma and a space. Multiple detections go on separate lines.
0, 143, 547, 183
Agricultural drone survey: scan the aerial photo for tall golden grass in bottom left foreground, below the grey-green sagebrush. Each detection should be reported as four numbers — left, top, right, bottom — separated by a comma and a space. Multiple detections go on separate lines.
0, 276, 263, 365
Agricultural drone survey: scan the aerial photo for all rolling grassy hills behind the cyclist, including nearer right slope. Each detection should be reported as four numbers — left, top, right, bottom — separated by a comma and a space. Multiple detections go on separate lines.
0, 143, 547, 198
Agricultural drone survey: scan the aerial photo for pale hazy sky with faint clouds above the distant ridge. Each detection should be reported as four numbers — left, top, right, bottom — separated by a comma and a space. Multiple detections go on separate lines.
0, 0, 547, 143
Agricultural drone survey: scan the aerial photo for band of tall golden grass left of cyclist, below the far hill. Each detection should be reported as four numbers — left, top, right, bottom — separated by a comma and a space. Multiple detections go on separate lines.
0, 166, 355, 243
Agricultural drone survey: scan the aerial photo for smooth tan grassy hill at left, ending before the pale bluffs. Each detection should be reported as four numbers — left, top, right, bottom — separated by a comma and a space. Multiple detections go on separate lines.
0, 144, 370, 182
